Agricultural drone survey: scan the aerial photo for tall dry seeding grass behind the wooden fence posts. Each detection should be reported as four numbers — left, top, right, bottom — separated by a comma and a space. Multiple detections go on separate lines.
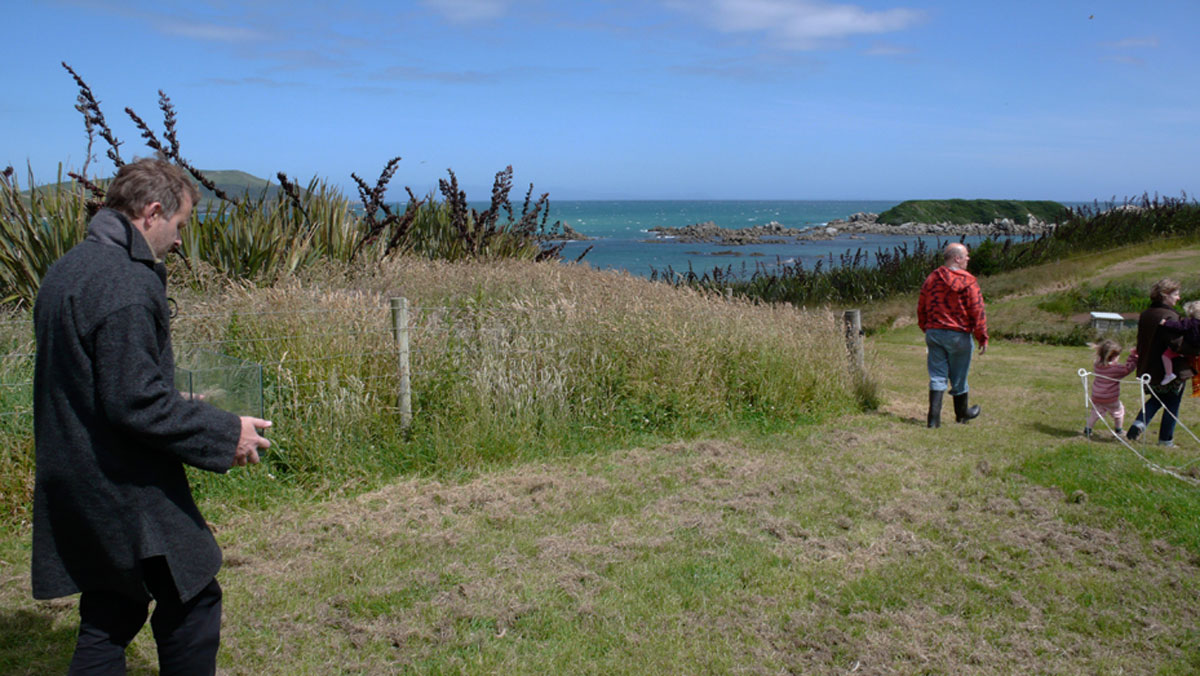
0, 257, 862, 514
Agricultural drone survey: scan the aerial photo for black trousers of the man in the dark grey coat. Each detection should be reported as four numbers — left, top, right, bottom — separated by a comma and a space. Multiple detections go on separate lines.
68, 558, 221, 676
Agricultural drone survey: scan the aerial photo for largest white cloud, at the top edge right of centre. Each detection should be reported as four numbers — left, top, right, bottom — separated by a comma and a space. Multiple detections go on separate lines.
664, 0, 925, 49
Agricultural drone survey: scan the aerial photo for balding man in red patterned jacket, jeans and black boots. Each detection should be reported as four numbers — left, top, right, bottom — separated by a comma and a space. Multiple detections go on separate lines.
917, 243, 988, 427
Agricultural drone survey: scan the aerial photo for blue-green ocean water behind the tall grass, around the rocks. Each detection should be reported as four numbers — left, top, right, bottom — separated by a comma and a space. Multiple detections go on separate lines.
540, 199, 937, 276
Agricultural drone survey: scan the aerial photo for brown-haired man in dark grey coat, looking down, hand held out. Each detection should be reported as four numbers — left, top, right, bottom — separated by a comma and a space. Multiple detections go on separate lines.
32, 158, 270, 674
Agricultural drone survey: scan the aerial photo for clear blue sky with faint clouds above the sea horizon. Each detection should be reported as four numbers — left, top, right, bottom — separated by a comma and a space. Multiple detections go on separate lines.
0, 0, 1200, 201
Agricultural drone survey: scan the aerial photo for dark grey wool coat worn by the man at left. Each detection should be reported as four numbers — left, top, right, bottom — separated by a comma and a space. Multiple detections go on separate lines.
32, 209, 241, 600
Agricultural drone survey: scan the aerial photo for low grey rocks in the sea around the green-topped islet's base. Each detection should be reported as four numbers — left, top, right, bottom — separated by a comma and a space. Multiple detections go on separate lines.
649, 211, 1057, 246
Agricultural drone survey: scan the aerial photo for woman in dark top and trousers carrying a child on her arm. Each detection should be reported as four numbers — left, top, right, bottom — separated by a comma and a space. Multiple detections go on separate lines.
1126, 279, 1194, 445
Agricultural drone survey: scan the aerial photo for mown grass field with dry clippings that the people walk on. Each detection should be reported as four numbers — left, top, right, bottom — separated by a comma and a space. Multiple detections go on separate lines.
0, 252, 1200, 675
